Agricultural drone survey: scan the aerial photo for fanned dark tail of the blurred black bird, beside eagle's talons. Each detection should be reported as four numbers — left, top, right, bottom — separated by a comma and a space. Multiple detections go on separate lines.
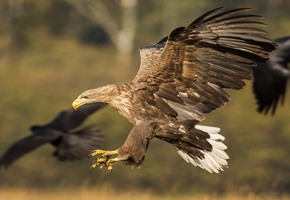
53, 126, 104, 160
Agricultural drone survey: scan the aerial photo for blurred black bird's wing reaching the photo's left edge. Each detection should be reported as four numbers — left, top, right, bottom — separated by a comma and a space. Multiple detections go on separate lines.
0, 130, 62, 168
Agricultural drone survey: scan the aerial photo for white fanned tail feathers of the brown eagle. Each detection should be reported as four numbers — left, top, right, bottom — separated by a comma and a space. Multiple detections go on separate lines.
174, 125, 229, 173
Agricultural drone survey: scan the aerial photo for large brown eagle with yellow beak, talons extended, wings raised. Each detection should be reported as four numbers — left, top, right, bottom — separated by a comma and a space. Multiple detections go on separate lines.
73, 8, 274, 173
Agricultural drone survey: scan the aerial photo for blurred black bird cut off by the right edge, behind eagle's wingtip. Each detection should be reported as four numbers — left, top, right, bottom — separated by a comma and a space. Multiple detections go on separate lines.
253, 36, 290, 115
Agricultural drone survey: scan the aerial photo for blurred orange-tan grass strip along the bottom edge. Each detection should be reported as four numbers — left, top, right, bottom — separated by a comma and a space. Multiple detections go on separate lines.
0, 188, 290, 200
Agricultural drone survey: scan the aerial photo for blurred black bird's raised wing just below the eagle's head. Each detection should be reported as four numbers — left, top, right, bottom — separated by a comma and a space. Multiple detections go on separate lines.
47, 103, 106, 130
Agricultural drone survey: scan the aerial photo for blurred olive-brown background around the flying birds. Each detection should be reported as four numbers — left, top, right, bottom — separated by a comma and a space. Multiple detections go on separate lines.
0, 0, 290, 197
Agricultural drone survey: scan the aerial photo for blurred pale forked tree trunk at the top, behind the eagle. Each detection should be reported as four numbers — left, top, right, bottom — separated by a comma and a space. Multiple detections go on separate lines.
66, 0, 137, 57
